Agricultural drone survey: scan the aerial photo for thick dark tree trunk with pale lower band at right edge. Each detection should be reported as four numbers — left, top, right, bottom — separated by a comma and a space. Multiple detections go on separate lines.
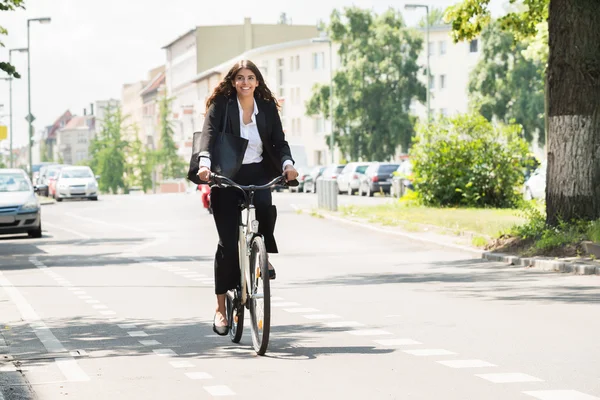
546, 0, 600, 225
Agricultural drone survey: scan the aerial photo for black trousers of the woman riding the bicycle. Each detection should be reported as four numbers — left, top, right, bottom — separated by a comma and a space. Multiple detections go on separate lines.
210, 163, 277, 294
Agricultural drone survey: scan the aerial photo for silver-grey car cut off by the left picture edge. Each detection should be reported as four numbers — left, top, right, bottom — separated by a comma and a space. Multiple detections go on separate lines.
0, 169, 42, 238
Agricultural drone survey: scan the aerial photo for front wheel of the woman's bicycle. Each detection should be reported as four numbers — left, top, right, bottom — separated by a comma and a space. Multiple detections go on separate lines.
248, 236, 271, 356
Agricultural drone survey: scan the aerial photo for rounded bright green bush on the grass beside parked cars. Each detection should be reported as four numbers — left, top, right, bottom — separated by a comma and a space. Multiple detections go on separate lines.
410, 115, 530, 208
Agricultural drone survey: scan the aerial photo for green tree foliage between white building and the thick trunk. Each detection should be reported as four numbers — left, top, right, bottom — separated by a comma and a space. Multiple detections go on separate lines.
469, 22, 545, 145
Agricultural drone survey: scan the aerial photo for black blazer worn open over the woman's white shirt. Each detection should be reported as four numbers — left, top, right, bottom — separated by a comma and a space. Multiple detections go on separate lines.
198, 94, 294, 179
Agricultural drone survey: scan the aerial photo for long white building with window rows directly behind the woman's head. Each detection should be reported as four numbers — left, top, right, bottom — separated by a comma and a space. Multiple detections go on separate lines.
194, 38, 339, 166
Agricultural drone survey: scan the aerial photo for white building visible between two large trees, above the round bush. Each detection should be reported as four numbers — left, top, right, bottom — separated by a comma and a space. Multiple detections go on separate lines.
411, 25, 481, 119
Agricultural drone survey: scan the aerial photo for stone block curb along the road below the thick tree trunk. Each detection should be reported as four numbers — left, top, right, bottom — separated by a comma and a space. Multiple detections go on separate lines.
482, 252, 600, 275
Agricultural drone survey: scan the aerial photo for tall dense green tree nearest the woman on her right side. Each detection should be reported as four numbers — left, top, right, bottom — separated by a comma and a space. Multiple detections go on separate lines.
306, 7, 425, 160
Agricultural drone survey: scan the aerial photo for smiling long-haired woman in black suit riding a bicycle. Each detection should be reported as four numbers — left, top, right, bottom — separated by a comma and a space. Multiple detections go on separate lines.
198, 60, 298, 336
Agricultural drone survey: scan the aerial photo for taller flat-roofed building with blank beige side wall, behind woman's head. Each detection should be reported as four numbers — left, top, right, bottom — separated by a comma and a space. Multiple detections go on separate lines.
163, 18, 318, 157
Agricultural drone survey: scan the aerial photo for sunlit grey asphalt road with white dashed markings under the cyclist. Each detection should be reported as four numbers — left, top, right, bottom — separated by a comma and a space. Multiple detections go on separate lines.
0, 193, 600, 400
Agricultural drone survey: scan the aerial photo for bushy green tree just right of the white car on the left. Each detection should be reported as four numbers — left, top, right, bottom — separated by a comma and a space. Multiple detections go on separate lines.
90, 105, 128, 194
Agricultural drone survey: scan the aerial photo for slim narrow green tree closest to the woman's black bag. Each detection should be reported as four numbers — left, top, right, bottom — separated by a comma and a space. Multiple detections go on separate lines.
157, 95, 185, 179
